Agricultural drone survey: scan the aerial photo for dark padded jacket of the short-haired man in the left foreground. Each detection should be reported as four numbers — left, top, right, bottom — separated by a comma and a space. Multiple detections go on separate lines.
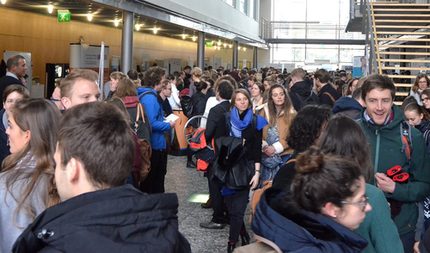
13, 185, 191, 253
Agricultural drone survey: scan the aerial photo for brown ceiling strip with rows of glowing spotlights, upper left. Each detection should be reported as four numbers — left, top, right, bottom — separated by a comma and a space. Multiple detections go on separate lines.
0, 0, 245, 47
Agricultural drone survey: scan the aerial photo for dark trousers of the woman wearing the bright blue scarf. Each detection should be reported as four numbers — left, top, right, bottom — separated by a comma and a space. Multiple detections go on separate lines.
224, 189, 249, 242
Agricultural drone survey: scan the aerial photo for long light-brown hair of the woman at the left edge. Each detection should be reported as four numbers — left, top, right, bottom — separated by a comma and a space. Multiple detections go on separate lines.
2, 98, 61, 221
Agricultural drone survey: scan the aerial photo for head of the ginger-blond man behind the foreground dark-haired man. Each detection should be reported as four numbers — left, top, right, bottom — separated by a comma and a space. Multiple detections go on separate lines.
60, 69, 100, 110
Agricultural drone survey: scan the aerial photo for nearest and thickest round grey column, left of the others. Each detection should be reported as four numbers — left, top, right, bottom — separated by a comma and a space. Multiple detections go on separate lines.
121, 11, 134, 73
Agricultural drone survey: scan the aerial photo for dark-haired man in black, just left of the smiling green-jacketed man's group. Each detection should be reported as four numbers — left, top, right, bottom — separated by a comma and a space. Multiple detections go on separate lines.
314, 69, 340, 107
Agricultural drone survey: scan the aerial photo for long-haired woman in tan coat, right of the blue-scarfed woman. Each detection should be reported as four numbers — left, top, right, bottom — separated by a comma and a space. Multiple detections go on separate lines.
260, 84, 296, 185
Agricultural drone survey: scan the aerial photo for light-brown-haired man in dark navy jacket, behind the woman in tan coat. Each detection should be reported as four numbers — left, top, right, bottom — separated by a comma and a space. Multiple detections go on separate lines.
289, 68, 318, 111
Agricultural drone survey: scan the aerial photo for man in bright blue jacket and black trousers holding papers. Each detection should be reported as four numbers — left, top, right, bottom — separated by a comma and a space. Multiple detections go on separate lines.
137, 66, 175, 193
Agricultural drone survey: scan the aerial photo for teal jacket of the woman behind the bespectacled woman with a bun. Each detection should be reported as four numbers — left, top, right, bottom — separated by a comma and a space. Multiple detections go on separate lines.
355, 184, 403, 253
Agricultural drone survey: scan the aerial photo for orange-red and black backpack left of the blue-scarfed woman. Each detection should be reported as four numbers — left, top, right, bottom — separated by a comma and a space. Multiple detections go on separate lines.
189, 128, 215, 172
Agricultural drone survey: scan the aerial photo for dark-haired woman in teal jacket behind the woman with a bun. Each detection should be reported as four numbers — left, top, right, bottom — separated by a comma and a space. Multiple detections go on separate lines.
318, 116, 403, 253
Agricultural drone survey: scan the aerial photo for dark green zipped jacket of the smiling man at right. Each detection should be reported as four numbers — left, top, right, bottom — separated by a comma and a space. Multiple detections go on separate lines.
359, 106, 430, 235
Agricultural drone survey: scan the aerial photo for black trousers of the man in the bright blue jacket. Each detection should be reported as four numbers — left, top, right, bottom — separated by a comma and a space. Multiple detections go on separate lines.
141, 150, 167, 193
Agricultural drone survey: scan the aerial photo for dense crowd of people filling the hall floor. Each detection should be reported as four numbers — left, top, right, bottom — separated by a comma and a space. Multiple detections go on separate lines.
0, 55, 430, 253
